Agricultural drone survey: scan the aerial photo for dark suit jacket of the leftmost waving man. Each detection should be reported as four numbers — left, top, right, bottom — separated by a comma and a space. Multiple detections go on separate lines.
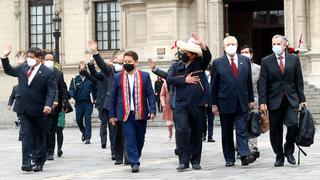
1, 58, 57, 116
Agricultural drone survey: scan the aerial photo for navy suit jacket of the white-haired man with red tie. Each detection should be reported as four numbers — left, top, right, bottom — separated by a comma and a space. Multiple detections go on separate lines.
211, 54, 254, 113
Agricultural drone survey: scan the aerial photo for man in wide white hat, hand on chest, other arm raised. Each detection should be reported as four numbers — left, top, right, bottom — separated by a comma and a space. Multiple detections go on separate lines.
167, 33, 211, 171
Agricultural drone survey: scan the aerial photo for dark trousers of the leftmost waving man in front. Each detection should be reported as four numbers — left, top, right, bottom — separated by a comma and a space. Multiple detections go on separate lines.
19, 113, 47, 165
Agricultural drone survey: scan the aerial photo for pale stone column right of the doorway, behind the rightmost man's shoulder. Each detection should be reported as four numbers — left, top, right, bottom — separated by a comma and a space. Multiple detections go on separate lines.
290, 0, 308, 52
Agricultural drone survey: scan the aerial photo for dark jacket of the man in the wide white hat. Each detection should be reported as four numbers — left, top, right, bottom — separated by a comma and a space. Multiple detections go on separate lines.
167, 49, 211, 109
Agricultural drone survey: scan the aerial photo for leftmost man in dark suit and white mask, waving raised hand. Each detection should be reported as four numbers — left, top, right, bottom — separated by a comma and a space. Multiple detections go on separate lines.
1, 47, 57, 172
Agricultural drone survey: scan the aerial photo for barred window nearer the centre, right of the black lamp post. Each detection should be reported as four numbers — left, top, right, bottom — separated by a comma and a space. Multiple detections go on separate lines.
96, 0, 120, 50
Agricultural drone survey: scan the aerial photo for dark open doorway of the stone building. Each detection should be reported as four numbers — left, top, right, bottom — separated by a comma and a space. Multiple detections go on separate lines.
224, 0, 284, 63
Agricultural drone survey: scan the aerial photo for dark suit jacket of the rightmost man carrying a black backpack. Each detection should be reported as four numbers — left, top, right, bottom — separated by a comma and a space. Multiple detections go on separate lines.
259, 53, 306, 110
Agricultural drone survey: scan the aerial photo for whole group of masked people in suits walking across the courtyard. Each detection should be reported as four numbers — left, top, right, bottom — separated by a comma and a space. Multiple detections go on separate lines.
1, 33, 306, 172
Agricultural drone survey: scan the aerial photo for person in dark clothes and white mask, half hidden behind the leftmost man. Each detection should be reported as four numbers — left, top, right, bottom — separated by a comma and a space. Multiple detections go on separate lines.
43, 53, 68, 160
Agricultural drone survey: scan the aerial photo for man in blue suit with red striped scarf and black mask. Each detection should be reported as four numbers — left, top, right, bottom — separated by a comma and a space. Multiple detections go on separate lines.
109, 51, 156, 173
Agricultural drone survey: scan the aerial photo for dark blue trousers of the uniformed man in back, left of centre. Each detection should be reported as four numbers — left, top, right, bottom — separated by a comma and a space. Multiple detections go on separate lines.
75, 102, 93, 140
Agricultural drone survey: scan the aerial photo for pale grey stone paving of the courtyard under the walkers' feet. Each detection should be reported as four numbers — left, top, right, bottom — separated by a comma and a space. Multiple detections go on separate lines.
0, 126, 320, 180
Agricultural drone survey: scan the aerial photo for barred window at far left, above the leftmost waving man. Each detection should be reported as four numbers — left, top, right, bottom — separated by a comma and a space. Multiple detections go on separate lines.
29, 0, 54, 50
